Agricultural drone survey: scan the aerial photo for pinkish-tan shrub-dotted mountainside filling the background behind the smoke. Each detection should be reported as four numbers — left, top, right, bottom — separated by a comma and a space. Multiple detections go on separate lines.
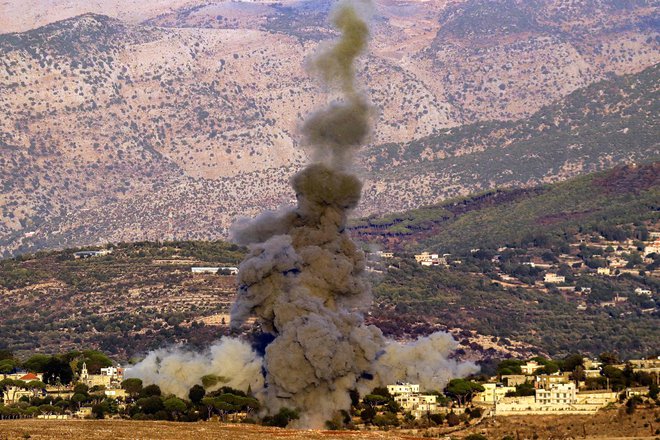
0, 0, 660, 255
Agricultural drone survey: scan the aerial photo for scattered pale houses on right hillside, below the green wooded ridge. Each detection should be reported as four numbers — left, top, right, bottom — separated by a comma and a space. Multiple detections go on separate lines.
367, 227, 660, 314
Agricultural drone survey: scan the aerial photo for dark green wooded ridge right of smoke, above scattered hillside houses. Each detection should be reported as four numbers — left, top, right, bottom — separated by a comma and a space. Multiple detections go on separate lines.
351, 162, 660, 252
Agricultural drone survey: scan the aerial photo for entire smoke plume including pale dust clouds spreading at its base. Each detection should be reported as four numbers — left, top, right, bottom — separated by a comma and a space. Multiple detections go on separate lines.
130, 0, 476, 427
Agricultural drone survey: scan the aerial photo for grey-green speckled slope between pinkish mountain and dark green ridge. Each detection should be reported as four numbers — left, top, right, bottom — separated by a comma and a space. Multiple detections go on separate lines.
365, 65, 660, 215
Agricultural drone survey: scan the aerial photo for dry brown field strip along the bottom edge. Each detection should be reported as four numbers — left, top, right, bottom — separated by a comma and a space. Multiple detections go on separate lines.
0, 407, 660, 440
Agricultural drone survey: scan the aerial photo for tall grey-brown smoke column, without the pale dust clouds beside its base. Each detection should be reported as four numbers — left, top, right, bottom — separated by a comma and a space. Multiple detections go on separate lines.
231, 2, 384, 427
